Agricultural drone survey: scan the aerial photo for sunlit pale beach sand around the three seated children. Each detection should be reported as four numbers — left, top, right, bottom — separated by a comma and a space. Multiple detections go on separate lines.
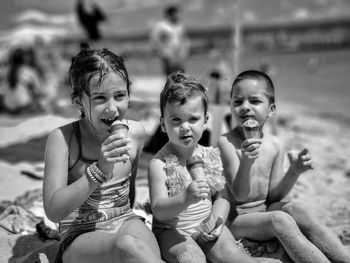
0, 73, 350, 262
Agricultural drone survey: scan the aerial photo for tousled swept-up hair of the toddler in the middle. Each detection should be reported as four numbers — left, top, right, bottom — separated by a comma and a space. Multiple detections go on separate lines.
160, 71, 208, 117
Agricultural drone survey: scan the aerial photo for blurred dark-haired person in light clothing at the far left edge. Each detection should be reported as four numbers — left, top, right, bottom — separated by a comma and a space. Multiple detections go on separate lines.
2, 47, 44, 113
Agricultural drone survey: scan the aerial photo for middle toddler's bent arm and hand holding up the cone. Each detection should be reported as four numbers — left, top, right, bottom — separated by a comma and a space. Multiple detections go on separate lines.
148, 159, 210, 220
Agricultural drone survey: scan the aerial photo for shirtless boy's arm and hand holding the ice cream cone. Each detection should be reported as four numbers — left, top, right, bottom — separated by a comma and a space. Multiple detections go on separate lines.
218, 137, 261, 201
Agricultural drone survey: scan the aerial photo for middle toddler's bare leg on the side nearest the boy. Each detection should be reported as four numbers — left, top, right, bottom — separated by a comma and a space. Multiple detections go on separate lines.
198, 226, 256, 263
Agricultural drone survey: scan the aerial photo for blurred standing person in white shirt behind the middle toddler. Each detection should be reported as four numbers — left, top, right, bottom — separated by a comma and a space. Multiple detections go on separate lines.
151, 5, 190, 77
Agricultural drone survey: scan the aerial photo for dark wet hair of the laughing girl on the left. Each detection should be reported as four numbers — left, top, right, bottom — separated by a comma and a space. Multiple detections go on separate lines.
69, 46, 131, 117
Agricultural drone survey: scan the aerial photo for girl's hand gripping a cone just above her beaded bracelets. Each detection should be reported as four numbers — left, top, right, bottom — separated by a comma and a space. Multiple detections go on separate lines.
98, 134, 131, 174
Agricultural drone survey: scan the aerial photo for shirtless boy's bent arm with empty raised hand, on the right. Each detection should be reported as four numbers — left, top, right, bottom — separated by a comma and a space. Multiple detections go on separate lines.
267, 139, 311, 204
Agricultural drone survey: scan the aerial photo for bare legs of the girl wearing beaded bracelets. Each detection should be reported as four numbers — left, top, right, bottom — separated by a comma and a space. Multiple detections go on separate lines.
63, 219, 164, 263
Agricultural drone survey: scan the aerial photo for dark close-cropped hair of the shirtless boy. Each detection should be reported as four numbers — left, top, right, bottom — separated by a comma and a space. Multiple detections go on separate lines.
231, 70, 275, 103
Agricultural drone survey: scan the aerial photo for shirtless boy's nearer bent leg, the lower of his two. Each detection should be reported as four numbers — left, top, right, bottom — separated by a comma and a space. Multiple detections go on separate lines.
229, 211, 330, 263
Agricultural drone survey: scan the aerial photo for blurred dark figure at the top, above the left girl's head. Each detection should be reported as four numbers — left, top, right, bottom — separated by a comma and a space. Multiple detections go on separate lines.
76, 0, 106, 42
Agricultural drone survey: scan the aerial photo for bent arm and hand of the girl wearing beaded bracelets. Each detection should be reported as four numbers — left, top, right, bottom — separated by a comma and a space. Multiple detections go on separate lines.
43, 128, 130, 222
